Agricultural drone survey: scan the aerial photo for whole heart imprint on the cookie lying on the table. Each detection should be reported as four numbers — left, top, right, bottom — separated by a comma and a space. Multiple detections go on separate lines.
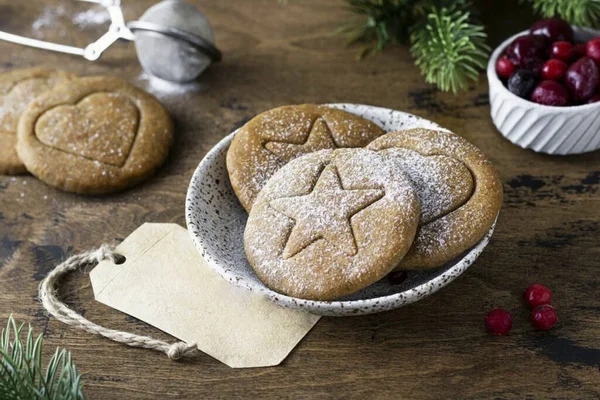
35, 92, 140, 167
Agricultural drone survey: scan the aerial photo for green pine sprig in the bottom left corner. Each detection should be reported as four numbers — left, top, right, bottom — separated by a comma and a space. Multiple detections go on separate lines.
0, 316, 85, 400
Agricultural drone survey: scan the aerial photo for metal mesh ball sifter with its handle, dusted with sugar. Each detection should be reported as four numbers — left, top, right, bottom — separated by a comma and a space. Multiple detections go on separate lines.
0, 0, 221, 82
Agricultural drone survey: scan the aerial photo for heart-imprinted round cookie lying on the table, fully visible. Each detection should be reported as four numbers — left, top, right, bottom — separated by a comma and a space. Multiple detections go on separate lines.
17, 77, 173, 194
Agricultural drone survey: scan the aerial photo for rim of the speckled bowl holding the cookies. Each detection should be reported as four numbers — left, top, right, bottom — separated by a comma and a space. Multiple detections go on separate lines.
185, 103, 498, 316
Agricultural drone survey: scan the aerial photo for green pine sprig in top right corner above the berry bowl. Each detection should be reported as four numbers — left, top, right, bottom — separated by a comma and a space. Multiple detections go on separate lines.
530, 0, 600, 28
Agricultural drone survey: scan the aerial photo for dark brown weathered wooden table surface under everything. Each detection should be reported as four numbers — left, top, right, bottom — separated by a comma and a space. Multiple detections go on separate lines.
0, 0, 600, 399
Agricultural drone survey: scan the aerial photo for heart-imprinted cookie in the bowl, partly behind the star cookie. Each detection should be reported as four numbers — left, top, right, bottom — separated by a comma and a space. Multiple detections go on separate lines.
368, 129, 503, 270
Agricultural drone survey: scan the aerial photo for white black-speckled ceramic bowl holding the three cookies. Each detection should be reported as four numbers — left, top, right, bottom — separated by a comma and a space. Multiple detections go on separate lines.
186, 104, 494, 316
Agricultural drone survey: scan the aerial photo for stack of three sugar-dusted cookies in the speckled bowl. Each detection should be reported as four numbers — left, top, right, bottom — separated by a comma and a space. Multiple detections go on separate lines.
227, 105, 502, 300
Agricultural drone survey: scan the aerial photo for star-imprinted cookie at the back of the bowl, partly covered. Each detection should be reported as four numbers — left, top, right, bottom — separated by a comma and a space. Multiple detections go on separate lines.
227, 104, 385, 212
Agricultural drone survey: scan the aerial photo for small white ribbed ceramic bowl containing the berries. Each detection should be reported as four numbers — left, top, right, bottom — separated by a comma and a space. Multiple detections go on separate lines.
487, 27, 600, 155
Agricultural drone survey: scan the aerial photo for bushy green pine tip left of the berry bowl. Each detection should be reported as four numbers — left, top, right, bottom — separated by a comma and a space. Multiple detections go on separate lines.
411, 3, 490, 93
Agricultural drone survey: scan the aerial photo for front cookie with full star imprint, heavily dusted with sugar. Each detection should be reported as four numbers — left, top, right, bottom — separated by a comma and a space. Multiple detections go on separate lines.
244, 149, 419, 300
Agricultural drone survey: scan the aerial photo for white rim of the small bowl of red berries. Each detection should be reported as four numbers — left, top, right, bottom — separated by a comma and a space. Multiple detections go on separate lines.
487, 25, 600, 114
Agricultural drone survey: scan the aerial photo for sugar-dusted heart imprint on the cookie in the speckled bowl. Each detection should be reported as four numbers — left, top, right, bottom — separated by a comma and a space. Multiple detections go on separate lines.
381, 147, 475, 225
